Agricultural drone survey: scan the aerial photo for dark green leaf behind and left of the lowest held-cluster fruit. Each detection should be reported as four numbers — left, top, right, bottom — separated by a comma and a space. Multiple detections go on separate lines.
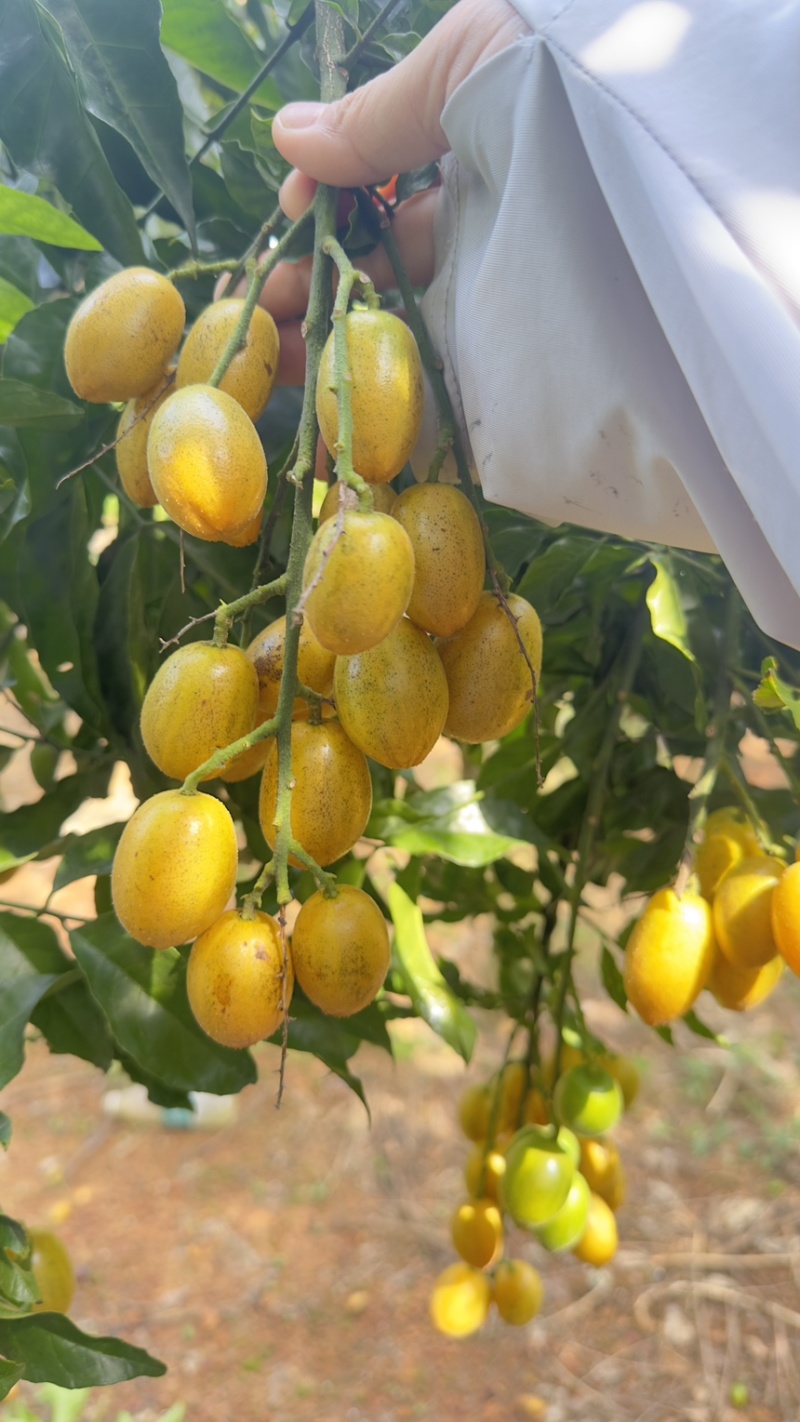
70, 913, 256, 1095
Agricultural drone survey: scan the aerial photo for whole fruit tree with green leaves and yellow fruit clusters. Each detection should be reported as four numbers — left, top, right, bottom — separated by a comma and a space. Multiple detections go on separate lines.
0, 0, 800, 1396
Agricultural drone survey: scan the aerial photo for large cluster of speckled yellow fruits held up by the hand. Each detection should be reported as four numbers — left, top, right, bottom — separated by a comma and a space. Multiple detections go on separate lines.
65, 269, 541, 1047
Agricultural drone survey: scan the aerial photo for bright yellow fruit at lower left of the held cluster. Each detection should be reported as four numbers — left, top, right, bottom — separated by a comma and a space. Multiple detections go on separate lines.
111, 791, 237, 948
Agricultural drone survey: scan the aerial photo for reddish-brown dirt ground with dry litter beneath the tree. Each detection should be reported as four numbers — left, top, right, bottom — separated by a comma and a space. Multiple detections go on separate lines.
0, 728, 800, 1422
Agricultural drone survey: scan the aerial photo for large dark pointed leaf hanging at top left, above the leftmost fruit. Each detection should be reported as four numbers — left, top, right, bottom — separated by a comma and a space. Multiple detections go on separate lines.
40, 0, 195, 239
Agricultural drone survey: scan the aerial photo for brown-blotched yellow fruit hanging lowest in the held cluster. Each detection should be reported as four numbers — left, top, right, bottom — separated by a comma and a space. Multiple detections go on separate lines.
186, 909, 294, 1047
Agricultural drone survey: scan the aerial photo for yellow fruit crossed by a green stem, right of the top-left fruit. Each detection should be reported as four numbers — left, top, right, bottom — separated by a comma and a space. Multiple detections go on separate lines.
176, 297, 280, 419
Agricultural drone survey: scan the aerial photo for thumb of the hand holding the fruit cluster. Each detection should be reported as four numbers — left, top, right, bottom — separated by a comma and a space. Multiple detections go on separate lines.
273, 0, 530, 188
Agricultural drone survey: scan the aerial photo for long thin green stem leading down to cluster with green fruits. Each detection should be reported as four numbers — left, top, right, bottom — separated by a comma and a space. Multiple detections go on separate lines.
551, 590, 649, 1085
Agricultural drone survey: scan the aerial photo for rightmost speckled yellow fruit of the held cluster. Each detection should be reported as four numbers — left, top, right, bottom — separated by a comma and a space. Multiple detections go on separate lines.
436, 593, 541, 745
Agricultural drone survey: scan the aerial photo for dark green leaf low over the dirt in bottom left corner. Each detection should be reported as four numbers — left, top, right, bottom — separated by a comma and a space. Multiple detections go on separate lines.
0, 1314, 166, 1388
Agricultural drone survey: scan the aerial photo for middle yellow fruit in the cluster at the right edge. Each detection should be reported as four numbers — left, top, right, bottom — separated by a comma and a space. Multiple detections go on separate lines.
713, 855, 786, 968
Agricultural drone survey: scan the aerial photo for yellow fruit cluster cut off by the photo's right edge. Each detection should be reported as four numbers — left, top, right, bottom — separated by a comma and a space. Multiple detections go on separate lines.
624, 808, 800, 1025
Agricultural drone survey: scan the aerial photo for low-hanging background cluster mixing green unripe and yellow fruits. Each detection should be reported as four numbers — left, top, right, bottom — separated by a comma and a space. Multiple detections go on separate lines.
431, 1044, 638, 1338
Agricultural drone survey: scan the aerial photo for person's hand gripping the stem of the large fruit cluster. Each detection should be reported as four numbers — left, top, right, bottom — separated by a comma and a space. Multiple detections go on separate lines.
244, 0, 529, 384
